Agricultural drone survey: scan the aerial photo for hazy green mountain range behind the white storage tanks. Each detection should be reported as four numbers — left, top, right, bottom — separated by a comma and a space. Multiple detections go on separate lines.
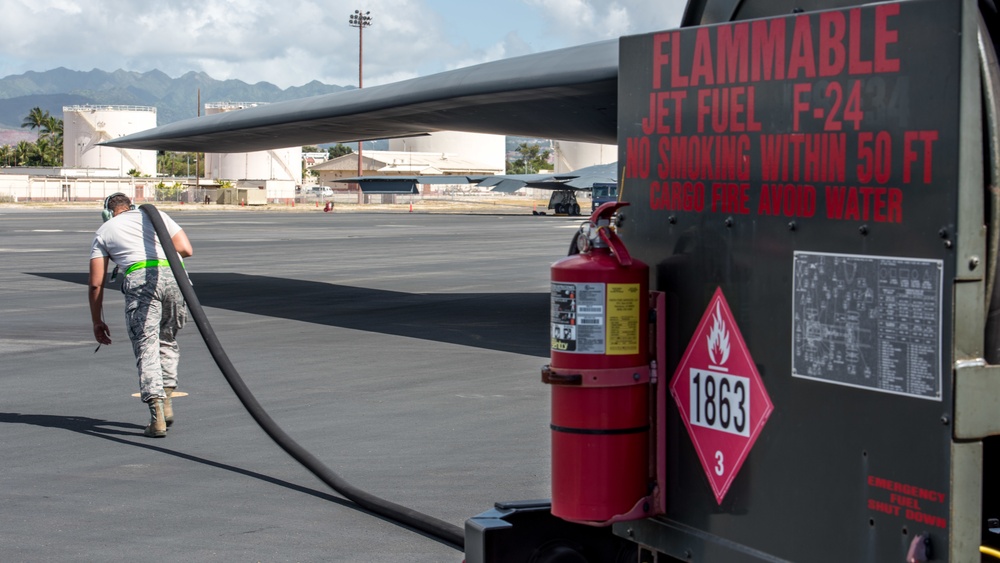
0, 68, 354, 129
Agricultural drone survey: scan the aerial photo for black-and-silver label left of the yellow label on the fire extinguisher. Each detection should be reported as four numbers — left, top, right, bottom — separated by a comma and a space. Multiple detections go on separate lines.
552, 282, 607, 354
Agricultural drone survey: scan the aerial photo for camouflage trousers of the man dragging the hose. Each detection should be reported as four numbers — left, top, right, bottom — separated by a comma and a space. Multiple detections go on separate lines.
122, 267, 187, 401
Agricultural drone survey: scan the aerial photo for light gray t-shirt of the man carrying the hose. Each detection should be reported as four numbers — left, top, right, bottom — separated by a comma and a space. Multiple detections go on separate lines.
90, 209, 181, 268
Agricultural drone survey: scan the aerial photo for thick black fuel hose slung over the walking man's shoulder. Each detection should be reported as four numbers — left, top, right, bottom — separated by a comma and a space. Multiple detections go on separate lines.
139, 203, 465, 551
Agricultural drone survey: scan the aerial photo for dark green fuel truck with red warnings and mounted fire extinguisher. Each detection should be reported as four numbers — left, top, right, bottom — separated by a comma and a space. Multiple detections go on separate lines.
466, 0, 1000, 563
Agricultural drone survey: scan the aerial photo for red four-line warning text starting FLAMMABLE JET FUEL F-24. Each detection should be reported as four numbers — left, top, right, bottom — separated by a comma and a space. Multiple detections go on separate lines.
623, 3, 941, 227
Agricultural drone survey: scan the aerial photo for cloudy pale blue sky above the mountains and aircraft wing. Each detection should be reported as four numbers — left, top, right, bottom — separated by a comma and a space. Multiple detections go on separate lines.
0, 0, 685, 88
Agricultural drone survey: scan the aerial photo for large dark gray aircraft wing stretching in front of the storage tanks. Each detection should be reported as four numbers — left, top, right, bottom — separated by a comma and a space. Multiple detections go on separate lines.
102, 39, 618, 153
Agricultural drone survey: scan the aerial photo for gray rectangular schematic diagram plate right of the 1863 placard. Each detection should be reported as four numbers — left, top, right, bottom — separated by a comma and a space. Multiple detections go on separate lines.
792, 252, 944, 401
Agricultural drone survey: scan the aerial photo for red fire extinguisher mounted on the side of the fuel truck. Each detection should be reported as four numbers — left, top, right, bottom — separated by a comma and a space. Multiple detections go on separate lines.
542, 202, 650, 524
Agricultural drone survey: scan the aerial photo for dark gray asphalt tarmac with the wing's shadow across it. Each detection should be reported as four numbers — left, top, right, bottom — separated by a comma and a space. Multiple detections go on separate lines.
0, 208, 580, 562
